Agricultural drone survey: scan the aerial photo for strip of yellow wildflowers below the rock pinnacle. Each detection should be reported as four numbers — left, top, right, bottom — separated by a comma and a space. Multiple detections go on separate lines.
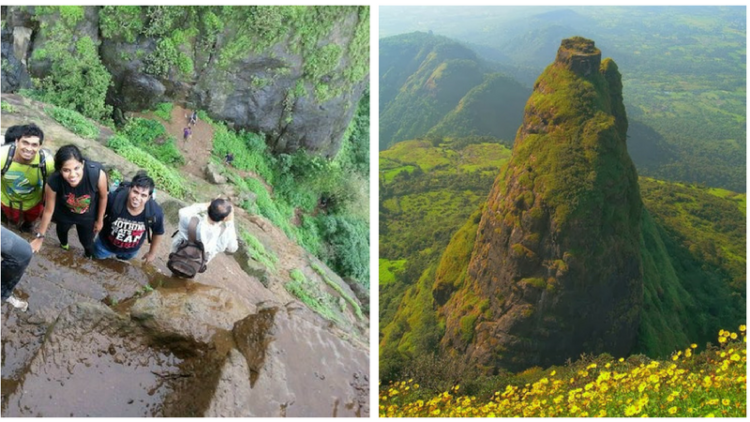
379, 325, 747, 417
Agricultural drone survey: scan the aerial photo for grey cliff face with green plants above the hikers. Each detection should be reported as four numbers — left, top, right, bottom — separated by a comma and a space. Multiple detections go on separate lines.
2, 6, 369, 156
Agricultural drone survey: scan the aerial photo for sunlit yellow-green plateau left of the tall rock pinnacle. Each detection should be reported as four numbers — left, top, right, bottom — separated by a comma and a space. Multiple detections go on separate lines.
379, 137, 510, 334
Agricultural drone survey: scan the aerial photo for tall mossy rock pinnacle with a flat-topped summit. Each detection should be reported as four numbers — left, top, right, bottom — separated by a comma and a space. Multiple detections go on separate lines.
439, 37, 643, 370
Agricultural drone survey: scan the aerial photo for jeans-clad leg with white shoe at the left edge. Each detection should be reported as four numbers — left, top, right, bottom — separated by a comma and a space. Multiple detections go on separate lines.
0, 227, 32, 312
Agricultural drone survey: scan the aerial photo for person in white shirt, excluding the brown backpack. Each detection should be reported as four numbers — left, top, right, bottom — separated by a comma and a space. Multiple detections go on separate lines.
172, 198, 239, 263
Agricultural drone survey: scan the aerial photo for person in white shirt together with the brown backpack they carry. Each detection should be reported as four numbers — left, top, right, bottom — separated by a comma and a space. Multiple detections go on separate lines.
167, 198, 238, 278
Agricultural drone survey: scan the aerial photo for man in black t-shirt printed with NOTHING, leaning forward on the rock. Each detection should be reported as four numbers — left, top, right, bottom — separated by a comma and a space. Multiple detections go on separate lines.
94, 173, 164, 264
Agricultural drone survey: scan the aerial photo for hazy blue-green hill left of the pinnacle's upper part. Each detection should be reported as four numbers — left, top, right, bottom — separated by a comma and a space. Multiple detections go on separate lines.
379, 32, 528, 149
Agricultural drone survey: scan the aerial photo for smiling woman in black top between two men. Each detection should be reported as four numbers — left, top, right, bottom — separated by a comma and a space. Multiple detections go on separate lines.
31, 145, 107, 258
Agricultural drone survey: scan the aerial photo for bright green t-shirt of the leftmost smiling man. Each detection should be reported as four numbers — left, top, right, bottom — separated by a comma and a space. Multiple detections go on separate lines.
0, 145, 55, 210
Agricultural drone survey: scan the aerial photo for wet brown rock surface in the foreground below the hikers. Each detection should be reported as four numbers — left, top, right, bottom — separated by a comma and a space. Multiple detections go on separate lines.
0, 190, 369, 417
